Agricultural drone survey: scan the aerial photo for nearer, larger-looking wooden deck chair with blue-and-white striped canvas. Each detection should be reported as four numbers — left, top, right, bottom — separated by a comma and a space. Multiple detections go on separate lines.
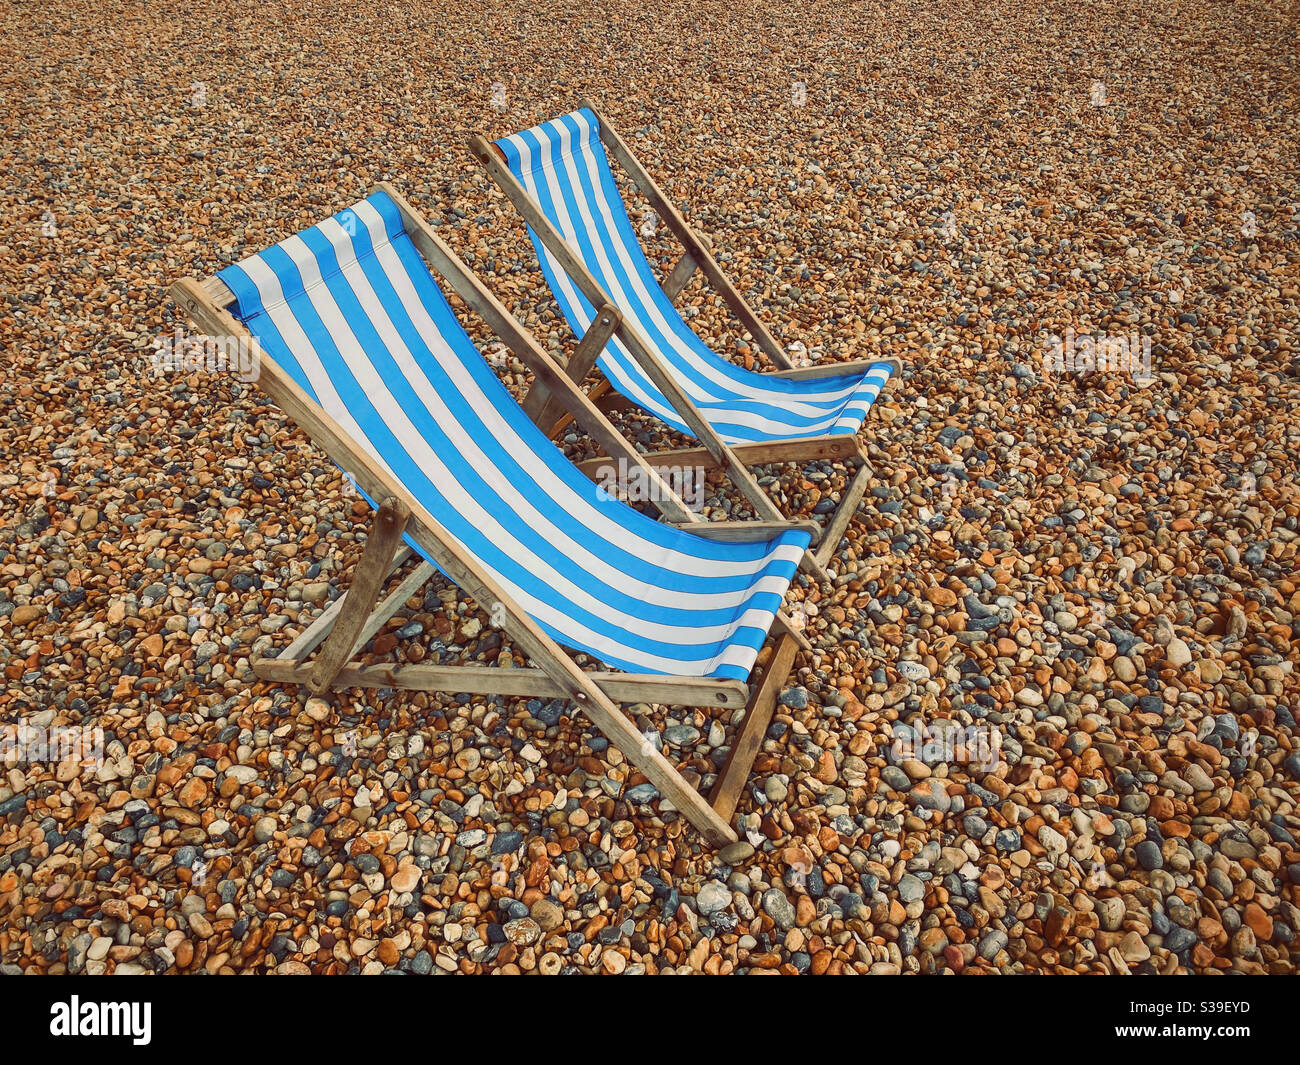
172, 185, 811, 845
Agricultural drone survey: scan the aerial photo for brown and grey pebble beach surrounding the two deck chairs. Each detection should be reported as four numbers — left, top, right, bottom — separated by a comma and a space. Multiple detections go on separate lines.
0, 0, 1300, 973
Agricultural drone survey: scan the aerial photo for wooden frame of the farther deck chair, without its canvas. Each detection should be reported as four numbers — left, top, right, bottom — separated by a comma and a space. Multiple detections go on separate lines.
469, 100, 902, 581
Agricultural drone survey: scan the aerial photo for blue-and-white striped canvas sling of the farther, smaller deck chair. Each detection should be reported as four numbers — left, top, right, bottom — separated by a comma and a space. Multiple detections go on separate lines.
497, 108, 891, 443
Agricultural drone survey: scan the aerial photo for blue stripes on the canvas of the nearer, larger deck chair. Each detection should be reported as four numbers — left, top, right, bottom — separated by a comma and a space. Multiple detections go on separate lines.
221, 187, 809, 679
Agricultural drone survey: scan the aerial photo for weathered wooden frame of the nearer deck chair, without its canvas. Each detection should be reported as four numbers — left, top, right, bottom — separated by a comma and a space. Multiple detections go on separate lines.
172, 183, 813, 847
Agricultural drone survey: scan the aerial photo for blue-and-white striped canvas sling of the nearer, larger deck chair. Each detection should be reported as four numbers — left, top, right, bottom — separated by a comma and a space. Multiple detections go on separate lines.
218, 192, 809, 680
